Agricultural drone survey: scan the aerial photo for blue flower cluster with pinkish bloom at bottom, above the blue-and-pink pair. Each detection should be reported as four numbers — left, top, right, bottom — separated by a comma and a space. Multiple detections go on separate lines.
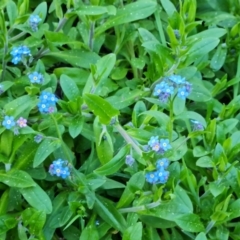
38, 92, 58, 113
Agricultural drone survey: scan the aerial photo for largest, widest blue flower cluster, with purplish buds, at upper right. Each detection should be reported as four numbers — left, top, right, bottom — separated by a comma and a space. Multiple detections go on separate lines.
153, 75, 192, 103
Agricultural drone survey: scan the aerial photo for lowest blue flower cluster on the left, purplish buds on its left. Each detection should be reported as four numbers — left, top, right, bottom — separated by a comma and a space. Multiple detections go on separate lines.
49, 159, 70, 179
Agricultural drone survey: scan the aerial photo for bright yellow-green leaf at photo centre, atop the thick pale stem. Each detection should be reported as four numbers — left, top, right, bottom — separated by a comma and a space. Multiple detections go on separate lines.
83, 94, 119, 124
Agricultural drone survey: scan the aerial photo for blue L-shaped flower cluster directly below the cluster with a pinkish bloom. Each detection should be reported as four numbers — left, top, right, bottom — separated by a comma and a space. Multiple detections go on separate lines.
146, 158, 169, 184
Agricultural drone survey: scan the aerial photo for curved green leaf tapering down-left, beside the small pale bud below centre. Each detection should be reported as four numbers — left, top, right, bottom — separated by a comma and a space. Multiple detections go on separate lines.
94, 145, 131, 176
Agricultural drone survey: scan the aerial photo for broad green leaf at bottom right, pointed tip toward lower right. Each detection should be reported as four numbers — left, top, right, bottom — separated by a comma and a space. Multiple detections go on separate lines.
175, 213, 205, 232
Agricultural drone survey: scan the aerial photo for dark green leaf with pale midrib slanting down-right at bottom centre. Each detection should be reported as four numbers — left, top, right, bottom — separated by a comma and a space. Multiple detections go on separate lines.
93, 196, 126, 232
